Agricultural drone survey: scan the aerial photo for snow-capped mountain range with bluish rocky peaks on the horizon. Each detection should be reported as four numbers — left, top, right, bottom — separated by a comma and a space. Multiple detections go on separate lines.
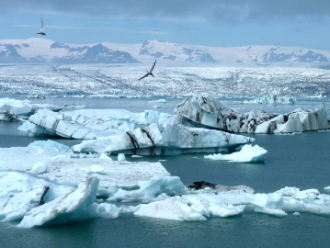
0, 38, 330, 66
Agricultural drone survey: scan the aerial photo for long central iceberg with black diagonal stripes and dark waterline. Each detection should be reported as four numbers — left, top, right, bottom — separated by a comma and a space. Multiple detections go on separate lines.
72, 123, 254, 155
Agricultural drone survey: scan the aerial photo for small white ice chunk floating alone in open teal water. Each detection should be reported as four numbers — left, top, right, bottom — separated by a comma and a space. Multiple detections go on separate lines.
204, 145, 267, 163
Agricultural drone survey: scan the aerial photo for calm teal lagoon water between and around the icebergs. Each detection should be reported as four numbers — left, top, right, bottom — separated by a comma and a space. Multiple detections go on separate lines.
0, 100, 330, 248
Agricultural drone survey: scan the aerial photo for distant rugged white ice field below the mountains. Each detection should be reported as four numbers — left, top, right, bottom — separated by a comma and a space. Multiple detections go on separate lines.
0, 64, 330, 98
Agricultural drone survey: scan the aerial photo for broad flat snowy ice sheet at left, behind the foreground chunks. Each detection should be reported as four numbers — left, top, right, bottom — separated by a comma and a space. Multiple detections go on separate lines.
0, 141, 170, 188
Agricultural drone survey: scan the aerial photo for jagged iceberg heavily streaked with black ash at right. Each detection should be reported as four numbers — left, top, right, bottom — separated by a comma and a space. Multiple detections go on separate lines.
175, 95, 328, 133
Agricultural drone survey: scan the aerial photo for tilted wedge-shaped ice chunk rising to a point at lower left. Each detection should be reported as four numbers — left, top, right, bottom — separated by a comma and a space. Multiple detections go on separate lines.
17, 177, 99, 228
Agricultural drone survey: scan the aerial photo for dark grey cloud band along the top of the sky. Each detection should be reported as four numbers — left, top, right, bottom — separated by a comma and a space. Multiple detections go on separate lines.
0, 0, 330, 22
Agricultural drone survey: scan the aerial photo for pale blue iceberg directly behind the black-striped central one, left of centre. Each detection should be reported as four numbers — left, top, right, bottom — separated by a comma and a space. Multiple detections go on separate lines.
18, 109, 172, 140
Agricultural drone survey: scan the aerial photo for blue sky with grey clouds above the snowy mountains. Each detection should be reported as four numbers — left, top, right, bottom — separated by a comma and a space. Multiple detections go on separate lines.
0, 0, 330, 50
